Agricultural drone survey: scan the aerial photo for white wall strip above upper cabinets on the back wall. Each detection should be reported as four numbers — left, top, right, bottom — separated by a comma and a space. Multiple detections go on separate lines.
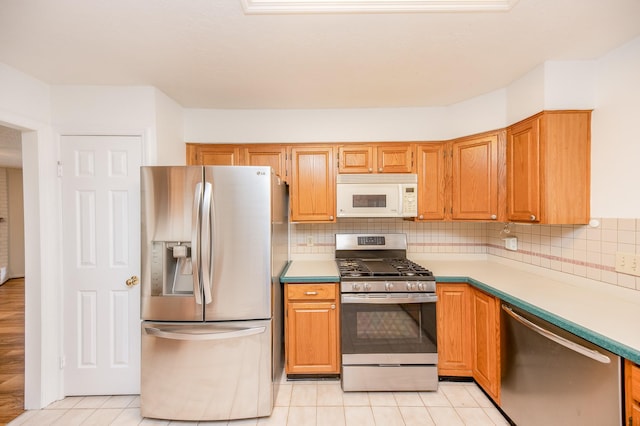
184, 108, 448, 143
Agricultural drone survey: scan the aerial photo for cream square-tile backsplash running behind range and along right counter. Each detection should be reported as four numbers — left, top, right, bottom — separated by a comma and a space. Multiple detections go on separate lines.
290, 218, 640, 291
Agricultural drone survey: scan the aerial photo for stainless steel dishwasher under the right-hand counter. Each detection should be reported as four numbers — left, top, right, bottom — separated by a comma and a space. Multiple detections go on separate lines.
500, 304, 624, 426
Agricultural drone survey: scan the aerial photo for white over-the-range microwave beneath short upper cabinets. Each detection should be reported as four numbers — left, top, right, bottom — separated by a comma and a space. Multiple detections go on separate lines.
336, 173, 418, 217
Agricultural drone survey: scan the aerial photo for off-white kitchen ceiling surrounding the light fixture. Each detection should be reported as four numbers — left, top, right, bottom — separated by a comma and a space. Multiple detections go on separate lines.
0, 0, 640, 109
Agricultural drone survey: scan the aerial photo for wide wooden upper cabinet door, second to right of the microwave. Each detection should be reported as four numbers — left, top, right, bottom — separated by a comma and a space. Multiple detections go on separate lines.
451, 134, 499, 220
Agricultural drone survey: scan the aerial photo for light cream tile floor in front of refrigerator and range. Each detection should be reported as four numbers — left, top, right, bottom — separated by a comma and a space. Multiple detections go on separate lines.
9, 379, 509, 426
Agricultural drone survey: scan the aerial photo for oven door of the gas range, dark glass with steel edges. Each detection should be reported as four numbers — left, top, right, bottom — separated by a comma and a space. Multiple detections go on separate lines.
341, 293, 438, 365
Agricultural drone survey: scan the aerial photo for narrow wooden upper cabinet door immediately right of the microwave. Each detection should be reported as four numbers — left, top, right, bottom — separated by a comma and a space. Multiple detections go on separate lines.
416, 143, 446, 220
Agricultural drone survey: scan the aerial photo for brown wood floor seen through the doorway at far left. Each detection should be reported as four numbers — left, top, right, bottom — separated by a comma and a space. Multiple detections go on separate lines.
0, 278, 24, 425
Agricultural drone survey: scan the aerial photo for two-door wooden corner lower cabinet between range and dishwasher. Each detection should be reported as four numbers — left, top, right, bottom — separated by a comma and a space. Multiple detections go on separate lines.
436, 283, 500, 404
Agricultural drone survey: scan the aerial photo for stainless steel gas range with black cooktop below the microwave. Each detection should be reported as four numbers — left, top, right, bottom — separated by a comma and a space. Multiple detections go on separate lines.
336, 234, 438, 391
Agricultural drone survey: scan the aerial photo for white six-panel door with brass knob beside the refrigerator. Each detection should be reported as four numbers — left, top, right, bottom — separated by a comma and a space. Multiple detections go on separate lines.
61, 136, 142, 395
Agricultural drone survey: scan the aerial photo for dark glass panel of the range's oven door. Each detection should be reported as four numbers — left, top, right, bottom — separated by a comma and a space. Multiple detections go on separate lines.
341, 303, 437, 354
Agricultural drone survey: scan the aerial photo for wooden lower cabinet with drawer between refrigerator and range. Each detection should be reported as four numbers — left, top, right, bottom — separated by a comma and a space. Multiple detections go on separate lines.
284, 283, 340, 375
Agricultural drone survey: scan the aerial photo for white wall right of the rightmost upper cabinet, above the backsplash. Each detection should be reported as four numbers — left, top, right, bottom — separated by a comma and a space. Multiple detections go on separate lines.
591, 37, 640, 218
